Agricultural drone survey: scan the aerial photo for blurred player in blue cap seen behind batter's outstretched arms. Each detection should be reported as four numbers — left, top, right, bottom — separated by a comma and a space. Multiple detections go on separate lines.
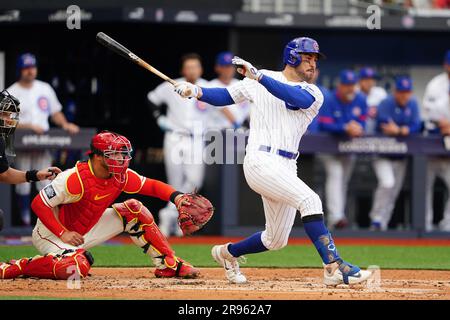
208, 51, 250, 129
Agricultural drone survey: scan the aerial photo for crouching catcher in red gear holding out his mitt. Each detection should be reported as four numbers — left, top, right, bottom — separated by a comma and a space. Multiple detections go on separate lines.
0, 131, 214, 279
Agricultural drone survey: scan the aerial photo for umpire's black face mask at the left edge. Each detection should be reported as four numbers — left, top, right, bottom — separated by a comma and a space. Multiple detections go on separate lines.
0, 90, 20, 140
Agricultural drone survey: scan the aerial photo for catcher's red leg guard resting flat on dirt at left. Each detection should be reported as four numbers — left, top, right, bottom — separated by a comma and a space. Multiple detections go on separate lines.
0, 249, 94, 280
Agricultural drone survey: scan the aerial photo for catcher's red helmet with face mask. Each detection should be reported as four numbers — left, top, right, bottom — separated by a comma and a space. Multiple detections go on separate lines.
89, 131, 133, 182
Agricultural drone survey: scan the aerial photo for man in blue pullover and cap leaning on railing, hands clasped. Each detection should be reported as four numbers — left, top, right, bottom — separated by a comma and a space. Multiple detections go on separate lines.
369, 76, 422, 231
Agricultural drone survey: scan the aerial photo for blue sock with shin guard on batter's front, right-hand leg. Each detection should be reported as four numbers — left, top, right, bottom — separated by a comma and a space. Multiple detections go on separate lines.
302, 214, 341, 264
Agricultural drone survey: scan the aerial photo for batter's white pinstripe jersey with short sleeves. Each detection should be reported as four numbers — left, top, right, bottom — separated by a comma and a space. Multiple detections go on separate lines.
227, 70, 323, 152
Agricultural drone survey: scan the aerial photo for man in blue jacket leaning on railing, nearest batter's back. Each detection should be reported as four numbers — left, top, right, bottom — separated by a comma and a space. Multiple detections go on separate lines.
319, 70, 367, 229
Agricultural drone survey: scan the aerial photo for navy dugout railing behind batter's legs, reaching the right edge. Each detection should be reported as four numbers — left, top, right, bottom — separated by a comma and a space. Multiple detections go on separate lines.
220, 134, 450, 238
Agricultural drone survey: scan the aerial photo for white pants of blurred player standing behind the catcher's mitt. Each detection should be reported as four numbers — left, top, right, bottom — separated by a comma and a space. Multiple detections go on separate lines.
158, 131, 205, 236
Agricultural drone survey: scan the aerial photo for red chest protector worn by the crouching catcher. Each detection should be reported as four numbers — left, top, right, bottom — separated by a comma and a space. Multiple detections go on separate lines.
59, 162, 126, 235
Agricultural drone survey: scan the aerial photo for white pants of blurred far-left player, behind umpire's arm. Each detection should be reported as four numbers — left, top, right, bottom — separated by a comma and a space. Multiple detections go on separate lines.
14, 151, 53, 196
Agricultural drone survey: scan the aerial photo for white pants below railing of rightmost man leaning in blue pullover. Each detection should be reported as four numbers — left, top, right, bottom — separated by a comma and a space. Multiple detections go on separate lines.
369, 158, 408, 229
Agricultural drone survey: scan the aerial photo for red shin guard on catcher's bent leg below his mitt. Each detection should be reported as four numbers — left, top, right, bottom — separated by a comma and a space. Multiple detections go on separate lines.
113, 199, 178, 269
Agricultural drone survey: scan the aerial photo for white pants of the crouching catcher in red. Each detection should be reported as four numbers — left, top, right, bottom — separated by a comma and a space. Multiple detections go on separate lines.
32, 208, 123, 254
